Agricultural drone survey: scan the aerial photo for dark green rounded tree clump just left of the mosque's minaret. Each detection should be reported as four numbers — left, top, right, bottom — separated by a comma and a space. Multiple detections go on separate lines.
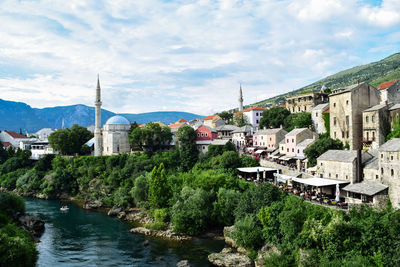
49, 124, 93, 155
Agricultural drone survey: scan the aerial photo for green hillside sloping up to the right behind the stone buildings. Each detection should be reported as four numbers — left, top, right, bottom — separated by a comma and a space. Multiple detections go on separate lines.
253, 53, 400, 106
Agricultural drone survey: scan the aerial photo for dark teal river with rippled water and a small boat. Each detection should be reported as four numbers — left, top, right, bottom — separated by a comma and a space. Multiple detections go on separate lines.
25, 198, 224, 267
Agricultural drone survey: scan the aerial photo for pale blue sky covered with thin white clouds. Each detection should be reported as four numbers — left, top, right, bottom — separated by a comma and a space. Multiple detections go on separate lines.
0, 0, 400, 115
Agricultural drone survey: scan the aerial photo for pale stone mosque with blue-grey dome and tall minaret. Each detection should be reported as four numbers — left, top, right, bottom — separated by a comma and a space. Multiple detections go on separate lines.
94, 76, 131, 156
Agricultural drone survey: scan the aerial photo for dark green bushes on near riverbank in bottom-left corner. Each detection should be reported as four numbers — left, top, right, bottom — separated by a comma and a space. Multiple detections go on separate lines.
0, 192, 38, 267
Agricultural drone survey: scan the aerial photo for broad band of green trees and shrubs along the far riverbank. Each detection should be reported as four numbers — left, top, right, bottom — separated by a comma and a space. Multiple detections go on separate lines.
0, 130, 400, 266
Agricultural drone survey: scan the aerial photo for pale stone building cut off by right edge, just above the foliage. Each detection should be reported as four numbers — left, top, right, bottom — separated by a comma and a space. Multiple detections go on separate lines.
379, 138, 400, 208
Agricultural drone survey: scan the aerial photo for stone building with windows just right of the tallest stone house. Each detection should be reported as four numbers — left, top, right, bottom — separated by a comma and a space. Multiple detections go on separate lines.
362, 103, 391, 149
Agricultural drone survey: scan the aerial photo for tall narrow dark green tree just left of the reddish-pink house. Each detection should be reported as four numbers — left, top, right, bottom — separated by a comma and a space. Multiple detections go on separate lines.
176, 126, 199, 171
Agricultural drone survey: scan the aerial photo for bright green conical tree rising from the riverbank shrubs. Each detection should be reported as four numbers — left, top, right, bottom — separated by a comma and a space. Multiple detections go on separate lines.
149, 163, 171, 208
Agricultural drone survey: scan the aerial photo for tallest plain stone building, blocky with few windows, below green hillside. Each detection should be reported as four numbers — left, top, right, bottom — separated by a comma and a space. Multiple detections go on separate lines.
329, 83, 379, 150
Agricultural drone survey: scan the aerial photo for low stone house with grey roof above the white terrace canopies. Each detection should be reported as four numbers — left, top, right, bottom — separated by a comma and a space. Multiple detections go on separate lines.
316, 150, 373, 183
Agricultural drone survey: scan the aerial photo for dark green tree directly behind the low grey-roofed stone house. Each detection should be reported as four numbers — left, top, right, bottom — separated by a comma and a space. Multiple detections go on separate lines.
304, 137, 343, 167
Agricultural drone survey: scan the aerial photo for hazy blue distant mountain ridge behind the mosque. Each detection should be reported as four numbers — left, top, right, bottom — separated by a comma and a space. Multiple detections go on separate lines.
0, 99, 204, 133
